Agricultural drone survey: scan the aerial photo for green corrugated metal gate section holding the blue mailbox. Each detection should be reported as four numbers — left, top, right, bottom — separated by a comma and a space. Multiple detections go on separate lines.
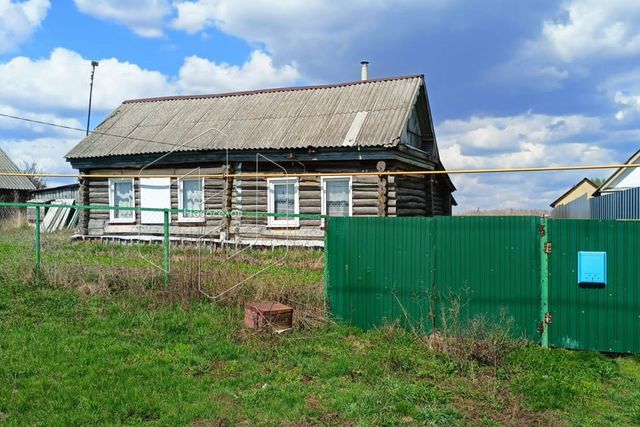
548, 220, 640, 353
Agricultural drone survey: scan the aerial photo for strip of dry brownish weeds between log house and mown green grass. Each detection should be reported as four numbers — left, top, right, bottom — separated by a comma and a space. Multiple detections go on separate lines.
0, 227, 326, 329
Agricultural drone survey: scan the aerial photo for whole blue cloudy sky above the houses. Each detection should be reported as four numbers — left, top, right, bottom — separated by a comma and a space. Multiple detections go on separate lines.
0, 0, 640, 212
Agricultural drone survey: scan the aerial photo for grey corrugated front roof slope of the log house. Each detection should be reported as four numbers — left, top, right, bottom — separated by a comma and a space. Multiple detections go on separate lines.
66, 75, 424, 159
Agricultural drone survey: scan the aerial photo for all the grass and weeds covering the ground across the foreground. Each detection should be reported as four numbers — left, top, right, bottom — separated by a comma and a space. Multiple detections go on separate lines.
0, 229, 640, 426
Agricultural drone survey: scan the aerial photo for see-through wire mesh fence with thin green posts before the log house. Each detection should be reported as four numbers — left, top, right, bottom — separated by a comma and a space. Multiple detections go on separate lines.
0, 203, 324, 324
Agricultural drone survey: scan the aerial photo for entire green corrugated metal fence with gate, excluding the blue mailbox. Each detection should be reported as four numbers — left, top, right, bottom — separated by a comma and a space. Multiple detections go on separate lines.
325, 217, 640, 353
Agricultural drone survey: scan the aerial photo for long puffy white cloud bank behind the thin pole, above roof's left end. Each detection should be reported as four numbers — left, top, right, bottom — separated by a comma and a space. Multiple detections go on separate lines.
0, 48, 299, 113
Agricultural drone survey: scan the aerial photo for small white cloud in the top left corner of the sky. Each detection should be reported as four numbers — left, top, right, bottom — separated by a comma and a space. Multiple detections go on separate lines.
0, 0, 50, 53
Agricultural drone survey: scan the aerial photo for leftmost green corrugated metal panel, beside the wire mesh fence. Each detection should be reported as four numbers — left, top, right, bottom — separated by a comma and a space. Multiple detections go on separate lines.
325, 217, 433, 332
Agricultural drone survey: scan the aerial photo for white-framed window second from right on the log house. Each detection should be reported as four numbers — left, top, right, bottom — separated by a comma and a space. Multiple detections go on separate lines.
267, 178, 300, 227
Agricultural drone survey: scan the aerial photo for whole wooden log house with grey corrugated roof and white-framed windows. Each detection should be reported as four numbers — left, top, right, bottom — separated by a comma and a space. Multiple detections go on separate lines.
66, 75, 455, 246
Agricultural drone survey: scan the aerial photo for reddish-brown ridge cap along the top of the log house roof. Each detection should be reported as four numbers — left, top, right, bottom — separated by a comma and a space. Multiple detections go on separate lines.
122, 74, 424, 104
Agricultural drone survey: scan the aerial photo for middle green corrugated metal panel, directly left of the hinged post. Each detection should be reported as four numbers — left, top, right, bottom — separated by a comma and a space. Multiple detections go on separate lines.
436, 216, 540, 341
